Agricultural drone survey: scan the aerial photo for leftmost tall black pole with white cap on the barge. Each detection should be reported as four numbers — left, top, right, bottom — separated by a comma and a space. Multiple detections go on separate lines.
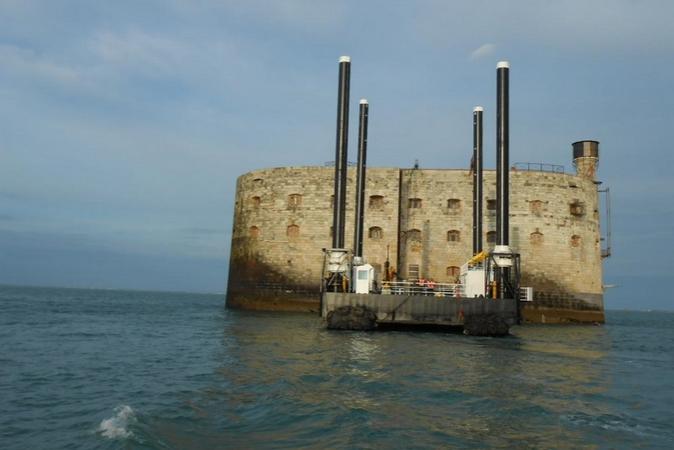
332, 56, 351, 248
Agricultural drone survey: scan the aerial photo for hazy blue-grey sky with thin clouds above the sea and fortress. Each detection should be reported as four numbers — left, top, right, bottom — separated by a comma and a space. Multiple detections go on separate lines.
0, 0, 674, 310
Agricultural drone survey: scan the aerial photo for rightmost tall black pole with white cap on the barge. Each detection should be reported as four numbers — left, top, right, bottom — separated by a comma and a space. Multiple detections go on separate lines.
496, 61, 510, 298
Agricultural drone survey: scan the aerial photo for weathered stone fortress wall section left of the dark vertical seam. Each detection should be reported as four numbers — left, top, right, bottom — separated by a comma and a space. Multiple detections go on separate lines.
227, 167, 399, 310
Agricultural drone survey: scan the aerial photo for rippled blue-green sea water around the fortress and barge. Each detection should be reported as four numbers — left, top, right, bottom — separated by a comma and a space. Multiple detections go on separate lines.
0, 286, 674, 449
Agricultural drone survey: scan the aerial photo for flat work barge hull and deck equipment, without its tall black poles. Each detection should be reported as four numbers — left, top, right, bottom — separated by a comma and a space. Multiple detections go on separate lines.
321, 250, 520, 336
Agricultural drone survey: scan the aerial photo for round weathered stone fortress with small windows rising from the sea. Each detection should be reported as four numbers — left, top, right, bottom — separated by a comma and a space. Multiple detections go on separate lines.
227, 141, 606, 323
